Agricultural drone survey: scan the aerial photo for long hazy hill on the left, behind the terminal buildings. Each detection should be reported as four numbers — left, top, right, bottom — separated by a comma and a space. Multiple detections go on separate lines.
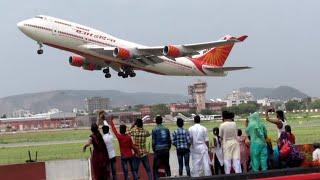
0, 90, 187, 114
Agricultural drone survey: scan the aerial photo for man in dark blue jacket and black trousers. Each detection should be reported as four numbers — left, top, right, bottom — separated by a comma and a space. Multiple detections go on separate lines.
152, 116, 171, 179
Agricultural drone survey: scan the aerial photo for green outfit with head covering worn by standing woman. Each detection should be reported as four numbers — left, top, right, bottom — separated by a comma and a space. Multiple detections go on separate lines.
246, 112, 268, 172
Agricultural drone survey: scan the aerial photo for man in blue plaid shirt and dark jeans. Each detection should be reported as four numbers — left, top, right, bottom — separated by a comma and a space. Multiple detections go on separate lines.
172, 118, 190, 176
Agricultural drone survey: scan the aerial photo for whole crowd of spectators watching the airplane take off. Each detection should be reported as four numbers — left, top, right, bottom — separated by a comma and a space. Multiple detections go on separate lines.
83, 109, 320, 180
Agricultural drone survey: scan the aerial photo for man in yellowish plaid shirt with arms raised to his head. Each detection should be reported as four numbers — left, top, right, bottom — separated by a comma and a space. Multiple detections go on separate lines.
128, 119, 152, 180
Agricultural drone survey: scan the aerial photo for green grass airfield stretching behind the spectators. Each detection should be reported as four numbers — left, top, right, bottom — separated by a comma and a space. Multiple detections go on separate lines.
0, 116, 320, 164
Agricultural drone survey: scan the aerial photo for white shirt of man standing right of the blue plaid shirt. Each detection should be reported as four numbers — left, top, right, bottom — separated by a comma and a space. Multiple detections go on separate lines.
189, 123, 209, 152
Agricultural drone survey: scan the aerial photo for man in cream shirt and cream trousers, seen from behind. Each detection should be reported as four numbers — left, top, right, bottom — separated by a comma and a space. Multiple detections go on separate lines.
219, 111, 241, 174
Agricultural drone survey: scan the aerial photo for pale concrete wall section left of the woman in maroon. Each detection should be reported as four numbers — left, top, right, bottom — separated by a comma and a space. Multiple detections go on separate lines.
45, 159, 90, 180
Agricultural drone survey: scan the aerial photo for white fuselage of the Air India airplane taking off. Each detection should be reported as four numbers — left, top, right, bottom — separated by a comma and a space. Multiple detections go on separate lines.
18, 16, 226, 76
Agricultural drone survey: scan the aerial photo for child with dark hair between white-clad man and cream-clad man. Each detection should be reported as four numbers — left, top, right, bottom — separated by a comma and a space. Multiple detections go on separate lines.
212, 127, 224, 175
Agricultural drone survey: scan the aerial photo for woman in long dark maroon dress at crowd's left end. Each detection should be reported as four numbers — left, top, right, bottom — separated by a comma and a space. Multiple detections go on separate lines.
83, 123, 110, 180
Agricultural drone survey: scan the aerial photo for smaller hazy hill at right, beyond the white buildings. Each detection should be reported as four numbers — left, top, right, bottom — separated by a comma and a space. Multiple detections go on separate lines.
240, 86, 308, 100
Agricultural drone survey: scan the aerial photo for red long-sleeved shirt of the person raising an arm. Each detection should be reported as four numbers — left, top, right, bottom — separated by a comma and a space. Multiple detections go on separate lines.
110, 121, 133, 157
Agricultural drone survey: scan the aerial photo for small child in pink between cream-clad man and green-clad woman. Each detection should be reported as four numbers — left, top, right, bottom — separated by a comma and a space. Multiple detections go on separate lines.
237, 129, 249, 173
